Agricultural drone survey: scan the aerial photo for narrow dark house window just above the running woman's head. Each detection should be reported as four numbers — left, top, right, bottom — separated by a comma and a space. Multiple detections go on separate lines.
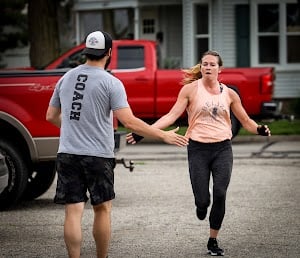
195, 4, 209, 62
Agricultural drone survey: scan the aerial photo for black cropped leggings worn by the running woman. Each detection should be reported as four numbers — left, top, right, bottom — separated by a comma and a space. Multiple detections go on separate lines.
188, 140, 233, 230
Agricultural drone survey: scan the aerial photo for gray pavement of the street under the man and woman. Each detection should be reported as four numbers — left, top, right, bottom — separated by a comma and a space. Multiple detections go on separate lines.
0, 140, 300, 258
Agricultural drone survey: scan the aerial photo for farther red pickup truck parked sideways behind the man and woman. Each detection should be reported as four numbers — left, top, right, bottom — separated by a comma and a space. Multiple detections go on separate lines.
45, 40, 277, 119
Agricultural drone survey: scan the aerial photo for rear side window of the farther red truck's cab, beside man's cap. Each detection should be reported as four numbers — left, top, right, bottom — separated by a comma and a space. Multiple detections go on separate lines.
117, 46, 145, 69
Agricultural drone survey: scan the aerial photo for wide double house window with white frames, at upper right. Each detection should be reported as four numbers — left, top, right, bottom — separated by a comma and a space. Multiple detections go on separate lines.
257, 3, 300, 65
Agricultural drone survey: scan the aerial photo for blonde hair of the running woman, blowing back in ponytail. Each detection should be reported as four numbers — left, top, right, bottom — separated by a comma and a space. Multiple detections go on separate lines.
182, 50, 223, 85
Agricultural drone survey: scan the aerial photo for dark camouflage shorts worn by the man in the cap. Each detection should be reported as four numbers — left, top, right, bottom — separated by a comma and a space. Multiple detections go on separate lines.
54, 153, 116, 205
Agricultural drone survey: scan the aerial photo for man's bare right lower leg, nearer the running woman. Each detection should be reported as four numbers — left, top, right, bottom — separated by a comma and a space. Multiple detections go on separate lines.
93, 201, 112, 258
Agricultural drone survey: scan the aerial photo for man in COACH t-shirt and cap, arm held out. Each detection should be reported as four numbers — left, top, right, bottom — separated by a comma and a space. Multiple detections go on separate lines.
46, 31, 188, 258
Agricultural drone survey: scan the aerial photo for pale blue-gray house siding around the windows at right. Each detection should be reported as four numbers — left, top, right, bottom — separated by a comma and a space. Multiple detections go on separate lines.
183, 0, 300, 99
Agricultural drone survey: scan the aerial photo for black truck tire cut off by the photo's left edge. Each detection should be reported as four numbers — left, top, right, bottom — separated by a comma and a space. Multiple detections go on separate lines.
0, 139, 28, 210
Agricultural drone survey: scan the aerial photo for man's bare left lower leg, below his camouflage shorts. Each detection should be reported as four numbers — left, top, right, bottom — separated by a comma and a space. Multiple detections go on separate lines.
64, 202, 84, 258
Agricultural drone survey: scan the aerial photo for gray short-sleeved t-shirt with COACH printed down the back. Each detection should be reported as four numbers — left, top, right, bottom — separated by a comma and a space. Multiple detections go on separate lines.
50, 64, 129, 158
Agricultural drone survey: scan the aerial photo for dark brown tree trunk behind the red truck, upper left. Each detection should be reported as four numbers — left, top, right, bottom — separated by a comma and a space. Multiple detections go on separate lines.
28, 0, 60, 68
